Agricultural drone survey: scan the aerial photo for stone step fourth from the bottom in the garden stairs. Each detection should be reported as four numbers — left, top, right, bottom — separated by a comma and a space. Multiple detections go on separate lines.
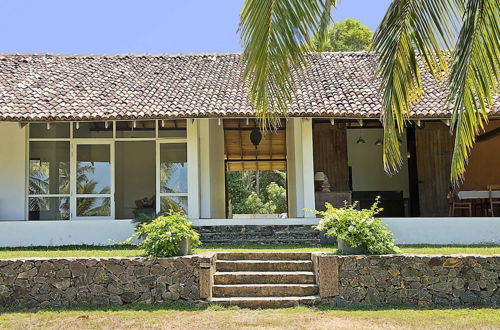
216, 260, 314, 272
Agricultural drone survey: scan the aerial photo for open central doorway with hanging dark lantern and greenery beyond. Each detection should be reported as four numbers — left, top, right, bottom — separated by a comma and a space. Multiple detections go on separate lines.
224, 120, 288, 218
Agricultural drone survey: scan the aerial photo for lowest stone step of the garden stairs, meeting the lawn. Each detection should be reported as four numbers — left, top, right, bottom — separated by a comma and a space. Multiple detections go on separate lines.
209, 295, 320, 308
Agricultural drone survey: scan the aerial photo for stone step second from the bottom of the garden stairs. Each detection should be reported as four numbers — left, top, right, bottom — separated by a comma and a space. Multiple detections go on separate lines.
213, 284, 319, 298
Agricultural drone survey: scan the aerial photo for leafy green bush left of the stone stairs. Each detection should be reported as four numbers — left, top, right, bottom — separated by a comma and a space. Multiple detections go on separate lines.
129, 212, 201, 257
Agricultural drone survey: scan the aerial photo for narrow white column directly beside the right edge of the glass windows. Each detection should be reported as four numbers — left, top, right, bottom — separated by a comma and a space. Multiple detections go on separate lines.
187, 119, 200, 219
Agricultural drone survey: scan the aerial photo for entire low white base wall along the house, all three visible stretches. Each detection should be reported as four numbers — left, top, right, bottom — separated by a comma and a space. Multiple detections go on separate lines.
0, 218, 500, 247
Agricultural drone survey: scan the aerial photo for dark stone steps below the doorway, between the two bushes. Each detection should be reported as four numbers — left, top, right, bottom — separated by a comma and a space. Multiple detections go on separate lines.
194, 225, 322, 244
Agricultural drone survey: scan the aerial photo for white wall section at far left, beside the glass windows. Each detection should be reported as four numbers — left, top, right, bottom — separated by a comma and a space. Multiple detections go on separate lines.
0, 123, 26, 220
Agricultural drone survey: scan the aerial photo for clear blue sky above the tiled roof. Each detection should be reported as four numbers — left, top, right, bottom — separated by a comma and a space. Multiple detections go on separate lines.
0, 0, 391, 54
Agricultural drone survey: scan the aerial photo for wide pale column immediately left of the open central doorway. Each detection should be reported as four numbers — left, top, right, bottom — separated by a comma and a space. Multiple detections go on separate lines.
199, 119, 226, 219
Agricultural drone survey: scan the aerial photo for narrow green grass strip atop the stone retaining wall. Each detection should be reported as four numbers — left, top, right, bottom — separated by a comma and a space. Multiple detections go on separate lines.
0, 244, 500, 259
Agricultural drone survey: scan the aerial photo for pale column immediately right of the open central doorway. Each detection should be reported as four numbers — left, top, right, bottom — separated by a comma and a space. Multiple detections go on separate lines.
286, 118, 315, 218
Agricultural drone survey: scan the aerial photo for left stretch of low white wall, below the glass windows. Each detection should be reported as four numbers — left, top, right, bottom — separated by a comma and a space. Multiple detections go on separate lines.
0, 220, 134, 247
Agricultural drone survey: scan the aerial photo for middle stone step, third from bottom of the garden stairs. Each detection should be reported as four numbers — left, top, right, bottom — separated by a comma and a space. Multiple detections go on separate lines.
214, 272, 316, 284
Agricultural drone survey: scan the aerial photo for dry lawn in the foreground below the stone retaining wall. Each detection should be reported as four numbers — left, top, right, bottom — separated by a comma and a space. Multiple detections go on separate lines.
0, 304, 500, 329
